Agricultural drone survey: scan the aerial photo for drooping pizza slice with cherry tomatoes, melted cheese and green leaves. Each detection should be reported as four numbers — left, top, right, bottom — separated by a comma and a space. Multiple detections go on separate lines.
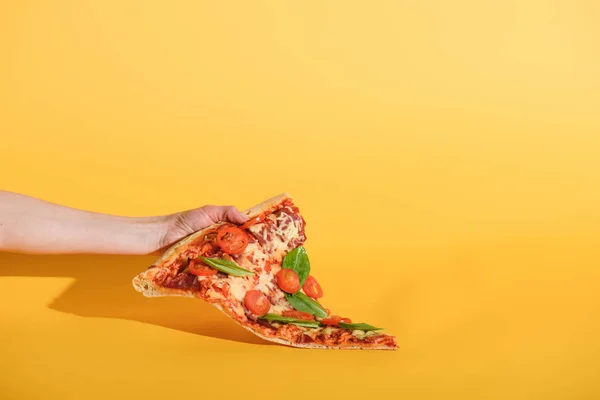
133, 193, 397, 350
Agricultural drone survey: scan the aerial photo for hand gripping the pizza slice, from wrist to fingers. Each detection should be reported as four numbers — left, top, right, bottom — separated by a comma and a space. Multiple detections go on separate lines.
159, 205, 248, 249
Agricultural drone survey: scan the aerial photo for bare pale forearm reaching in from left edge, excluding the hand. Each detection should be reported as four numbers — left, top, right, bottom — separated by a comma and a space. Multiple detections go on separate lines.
0, 191, 167, 254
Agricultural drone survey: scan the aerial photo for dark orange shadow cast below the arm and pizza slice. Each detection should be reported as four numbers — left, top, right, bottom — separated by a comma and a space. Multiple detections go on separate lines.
0, 252, 270, 344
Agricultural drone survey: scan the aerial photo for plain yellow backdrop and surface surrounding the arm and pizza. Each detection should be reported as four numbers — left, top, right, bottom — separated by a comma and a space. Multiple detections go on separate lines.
0, 0, 600, 399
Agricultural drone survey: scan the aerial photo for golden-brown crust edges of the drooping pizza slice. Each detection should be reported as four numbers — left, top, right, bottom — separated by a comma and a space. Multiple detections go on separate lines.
133, 193, 395, 350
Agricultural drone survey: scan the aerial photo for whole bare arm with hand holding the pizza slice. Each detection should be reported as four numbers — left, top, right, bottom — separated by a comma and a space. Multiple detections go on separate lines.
0, 191, 248, 255
